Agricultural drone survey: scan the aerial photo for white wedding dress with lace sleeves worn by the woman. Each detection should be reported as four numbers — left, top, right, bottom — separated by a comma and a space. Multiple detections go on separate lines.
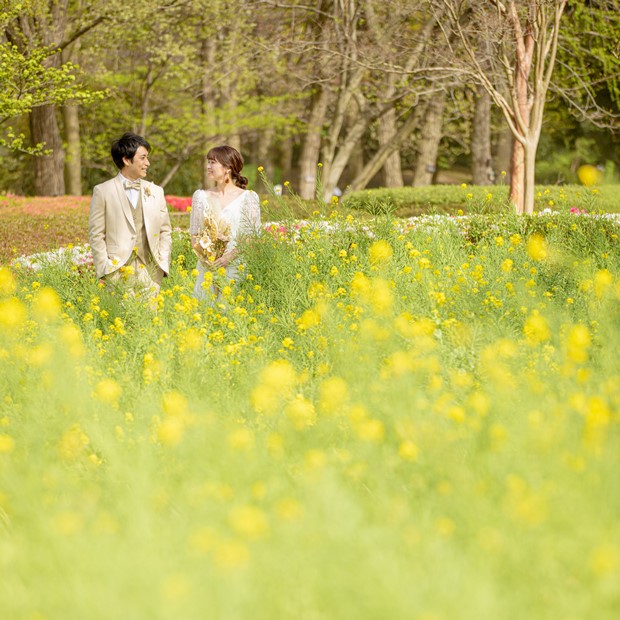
189, 189, 260, 300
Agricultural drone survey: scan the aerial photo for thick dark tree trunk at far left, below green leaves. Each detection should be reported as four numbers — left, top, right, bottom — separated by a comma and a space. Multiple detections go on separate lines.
30, 105, 65, 196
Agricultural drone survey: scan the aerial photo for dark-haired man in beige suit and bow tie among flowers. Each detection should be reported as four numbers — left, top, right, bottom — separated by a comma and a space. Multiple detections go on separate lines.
88, 133, 172, 296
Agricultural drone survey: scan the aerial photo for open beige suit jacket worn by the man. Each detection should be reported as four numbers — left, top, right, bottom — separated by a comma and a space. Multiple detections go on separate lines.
88, 176, 172, 278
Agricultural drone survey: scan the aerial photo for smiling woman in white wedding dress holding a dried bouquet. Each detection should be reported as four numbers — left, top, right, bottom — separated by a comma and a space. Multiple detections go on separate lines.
189, 145, 260, 300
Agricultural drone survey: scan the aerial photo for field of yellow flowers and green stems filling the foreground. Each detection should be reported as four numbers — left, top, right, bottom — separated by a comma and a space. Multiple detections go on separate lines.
0, 201, 620, 620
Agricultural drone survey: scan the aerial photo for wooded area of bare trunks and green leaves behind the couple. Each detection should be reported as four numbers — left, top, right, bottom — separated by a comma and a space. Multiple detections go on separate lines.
0, 0, 620, 212
